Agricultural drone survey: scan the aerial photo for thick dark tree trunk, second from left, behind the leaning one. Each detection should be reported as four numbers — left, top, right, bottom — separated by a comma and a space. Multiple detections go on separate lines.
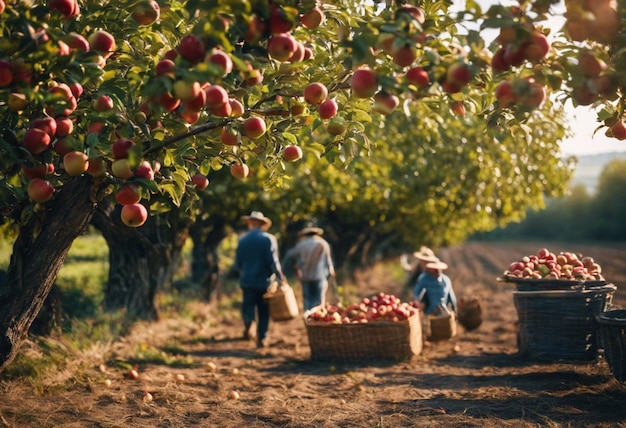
92, 206, 188, 319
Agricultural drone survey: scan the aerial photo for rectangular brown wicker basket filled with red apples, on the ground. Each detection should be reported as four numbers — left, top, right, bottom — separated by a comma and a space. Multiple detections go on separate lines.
304, 292, 422, 361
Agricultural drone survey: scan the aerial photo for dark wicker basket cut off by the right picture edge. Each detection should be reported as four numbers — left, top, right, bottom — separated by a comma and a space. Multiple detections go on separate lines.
596, 309, 626, 382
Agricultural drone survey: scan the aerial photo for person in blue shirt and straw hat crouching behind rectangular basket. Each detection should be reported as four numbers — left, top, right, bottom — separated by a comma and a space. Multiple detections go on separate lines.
413, 260, 457, 315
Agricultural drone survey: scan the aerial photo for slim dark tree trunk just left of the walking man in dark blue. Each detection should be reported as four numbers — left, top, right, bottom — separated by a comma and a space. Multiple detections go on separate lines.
189, 216, 226, 300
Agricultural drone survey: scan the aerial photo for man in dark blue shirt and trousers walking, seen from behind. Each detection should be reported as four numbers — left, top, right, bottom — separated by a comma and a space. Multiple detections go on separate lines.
235, 211, 285, 348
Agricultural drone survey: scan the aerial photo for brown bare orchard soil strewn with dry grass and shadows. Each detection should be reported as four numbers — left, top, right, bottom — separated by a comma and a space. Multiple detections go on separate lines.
0, 242, 626, 428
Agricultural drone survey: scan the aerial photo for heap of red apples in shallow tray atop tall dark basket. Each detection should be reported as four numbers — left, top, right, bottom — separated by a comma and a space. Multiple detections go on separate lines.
498, 248, 607, 291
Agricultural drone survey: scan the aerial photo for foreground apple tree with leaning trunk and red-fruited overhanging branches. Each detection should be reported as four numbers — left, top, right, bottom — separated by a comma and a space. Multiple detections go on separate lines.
0, 0, 623, 369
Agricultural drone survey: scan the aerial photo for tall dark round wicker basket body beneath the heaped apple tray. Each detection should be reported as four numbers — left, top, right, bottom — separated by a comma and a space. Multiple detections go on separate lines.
513, 284, 617, 361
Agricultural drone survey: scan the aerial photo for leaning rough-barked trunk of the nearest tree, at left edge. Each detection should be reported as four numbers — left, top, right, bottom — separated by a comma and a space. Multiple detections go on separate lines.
0, 176, 96, 371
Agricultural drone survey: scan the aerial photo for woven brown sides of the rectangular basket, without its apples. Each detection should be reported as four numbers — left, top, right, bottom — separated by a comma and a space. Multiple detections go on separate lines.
305, 313, 422, 361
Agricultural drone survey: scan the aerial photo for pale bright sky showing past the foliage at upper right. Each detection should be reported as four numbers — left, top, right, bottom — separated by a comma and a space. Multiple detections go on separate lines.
454, 0, 626, 156
